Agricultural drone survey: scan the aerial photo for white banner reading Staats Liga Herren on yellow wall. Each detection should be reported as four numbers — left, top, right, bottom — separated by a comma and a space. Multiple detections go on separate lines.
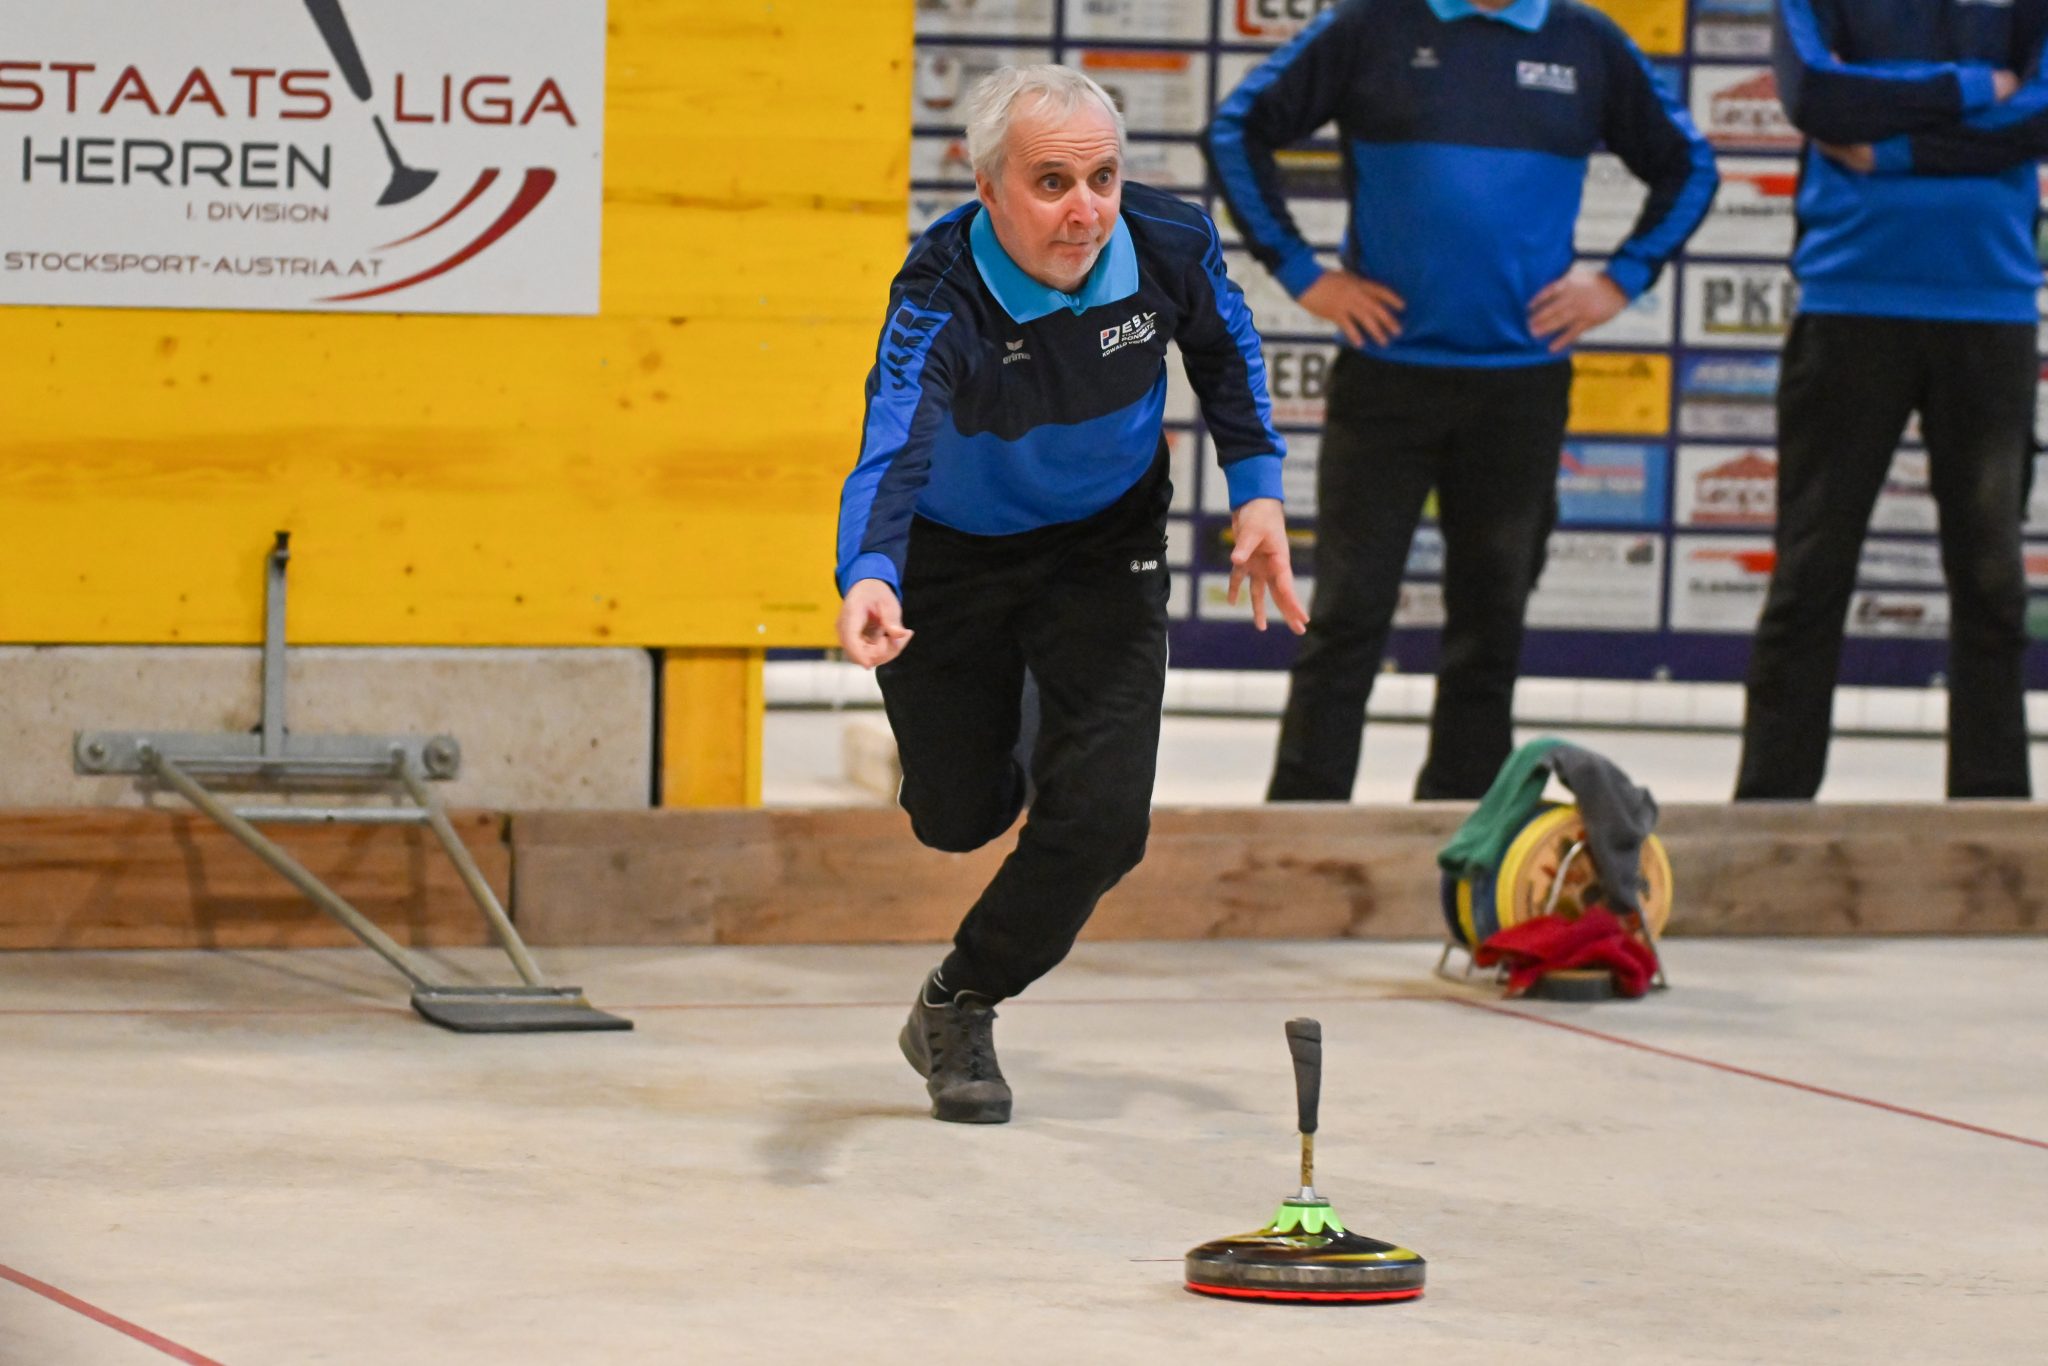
0, 0, 604, 313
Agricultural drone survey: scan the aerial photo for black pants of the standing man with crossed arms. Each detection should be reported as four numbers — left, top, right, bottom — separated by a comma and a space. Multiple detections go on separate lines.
1735, 313, 2036, 801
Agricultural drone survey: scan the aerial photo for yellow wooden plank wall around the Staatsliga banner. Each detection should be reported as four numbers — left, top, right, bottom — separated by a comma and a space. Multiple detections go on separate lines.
0, 0, 911, 651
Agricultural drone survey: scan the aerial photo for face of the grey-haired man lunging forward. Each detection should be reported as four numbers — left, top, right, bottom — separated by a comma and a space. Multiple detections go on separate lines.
975, 102, 1124, 293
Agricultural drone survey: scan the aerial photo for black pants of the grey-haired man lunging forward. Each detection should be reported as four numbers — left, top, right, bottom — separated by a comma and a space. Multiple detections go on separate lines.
879, 455, 1169, 999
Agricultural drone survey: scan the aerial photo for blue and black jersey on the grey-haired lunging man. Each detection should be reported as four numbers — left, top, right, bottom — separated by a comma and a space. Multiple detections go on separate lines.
838, 182, 1286, 592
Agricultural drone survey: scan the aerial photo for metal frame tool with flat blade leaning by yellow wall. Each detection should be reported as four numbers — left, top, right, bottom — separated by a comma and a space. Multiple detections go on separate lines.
72, 530, 633, 1034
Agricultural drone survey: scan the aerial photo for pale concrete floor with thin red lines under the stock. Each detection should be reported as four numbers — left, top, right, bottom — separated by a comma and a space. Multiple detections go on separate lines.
0, 940, 2048, 1366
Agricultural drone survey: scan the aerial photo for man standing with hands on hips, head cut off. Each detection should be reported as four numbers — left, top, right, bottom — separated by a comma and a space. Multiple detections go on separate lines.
1204, 0, 1718, 801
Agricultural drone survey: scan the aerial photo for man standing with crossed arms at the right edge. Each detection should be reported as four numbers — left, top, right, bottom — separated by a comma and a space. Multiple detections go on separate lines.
1735, 0, 2048, 799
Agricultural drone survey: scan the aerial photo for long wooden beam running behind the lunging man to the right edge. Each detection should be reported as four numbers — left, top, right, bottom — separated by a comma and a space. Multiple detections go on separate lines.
512, 803, 2048, 944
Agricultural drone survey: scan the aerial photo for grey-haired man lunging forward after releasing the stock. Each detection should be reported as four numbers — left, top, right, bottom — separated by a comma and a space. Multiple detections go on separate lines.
838, 66, 1305, 1124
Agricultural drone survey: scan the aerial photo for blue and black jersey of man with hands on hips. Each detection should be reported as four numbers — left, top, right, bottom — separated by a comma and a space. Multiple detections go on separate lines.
1204, 0, 1720, 365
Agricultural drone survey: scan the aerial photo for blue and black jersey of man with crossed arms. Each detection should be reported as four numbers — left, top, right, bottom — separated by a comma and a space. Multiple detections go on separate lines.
1772, 0, 2048, 322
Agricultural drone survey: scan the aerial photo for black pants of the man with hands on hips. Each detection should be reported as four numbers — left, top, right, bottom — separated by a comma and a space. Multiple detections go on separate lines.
1266, 350, 1571, 801
